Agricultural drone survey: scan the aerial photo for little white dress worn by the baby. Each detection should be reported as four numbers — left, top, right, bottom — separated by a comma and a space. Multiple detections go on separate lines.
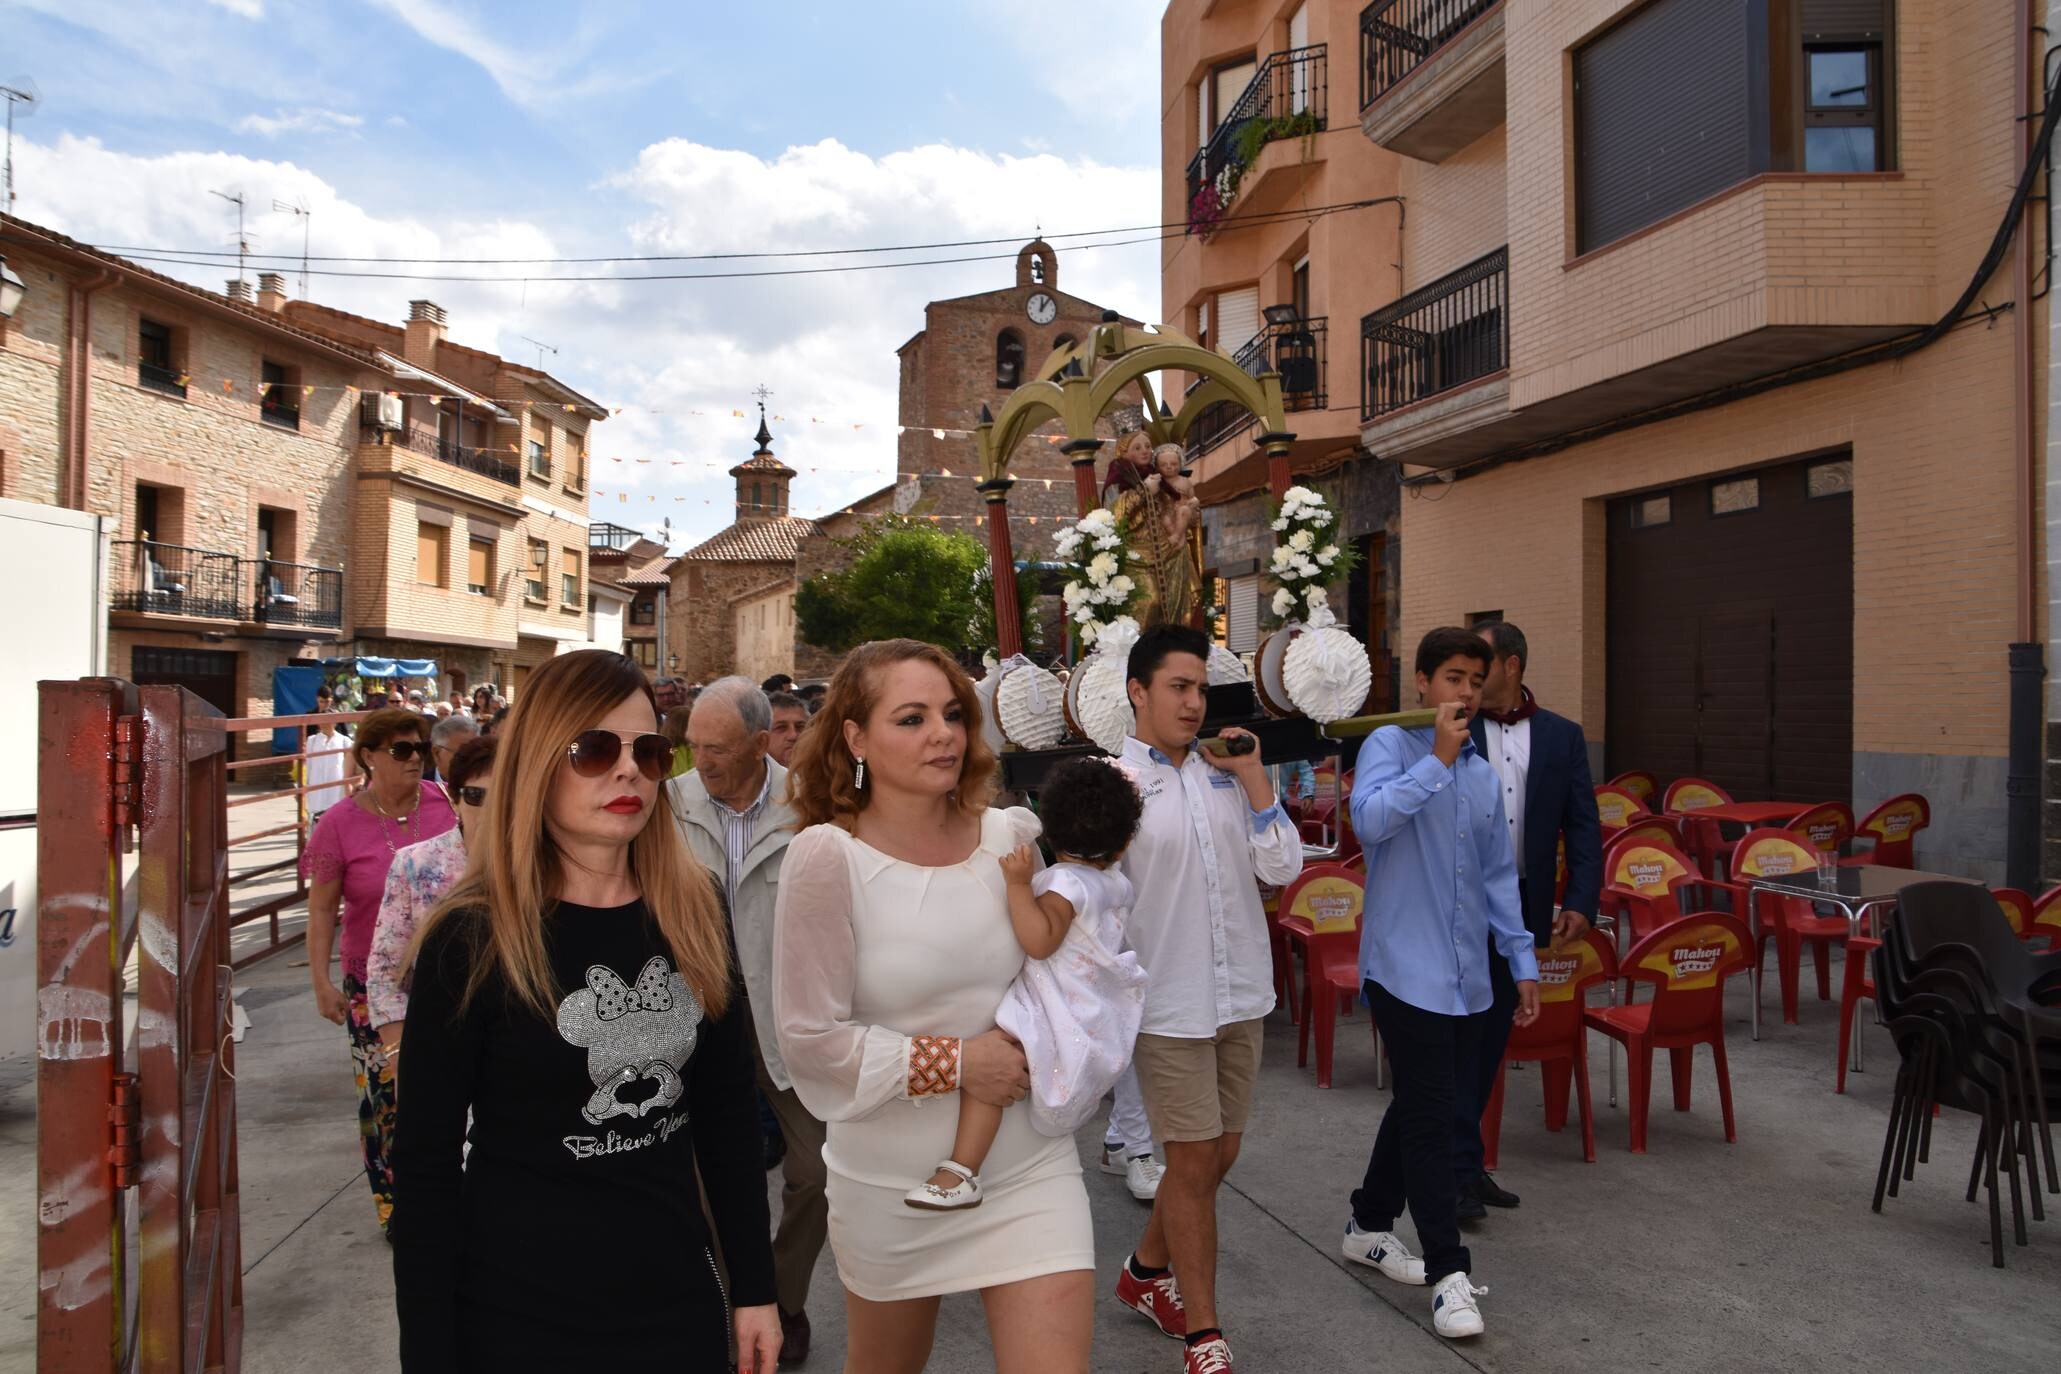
981, 863, 1146, 1137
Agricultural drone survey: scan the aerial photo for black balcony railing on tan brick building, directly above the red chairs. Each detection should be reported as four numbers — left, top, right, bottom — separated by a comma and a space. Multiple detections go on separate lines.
1360, 247, 1511, 422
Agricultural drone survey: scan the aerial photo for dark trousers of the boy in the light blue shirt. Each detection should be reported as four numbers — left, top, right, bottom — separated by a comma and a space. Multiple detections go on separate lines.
1352, 981, 1490, 1283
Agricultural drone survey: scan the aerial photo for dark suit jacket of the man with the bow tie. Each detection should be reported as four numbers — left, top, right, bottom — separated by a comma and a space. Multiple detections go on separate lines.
1469, 707, 1603, 948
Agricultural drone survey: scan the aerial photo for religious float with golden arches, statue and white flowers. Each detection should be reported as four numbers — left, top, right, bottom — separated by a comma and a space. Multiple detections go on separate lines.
960, 311, 1428, 791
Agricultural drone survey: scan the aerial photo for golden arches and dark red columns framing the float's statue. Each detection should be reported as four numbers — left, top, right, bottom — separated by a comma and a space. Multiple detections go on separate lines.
975, 311, 1294, 657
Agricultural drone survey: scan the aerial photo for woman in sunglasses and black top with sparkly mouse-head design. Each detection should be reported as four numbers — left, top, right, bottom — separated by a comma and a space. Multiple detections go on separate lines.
394, 651, 779, 1374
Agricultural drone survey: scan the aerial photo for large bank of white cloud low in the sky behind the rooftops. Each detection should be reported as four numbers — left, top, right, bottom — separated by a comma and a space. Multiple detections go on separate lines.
16, 136, 1158, 546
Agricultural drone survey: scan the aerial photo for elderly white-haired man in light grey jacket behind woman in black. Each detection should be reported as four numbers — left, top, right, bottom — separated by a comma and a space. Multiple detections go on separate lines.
670, 678, 831, 1366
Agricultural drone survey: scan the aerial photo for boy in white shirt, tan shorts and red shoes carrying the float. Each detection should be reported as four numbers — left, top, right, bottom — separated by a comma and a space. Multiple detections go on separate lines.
1117, 624, 1303, 1374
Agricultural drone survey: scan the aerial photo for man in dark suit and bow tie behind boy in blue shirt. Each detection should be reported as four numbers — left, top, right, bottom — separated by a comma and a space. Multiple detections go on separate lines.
1453, 620, 1603, 1220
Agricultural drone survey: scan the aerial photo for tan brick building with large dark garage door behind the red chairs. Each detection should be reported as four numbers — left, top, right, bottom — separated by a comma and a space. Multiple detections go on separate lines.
1333, 0, 2057, 882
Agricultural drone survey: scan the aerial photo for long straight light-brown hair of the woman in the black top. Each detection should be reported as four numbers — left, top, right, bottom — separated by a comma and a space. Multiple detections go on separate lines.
406, 649, 730, 1020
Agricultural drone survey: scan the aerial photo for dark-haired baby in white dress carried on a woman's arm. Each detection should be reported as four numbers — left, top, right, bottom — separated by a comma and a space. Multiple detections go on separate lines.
905, 758, 1146, 1211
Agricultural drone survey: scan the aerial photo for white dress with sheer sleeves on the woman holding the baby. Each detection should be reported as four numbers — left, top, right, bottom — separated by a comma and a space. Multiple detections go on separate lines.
773, 808, 1094, 1302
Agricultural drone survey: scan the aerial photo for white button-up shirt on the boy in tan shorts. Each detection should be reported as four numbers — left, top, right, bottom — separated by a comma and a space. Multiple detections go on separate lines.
1117, 737, 1303, 1040
